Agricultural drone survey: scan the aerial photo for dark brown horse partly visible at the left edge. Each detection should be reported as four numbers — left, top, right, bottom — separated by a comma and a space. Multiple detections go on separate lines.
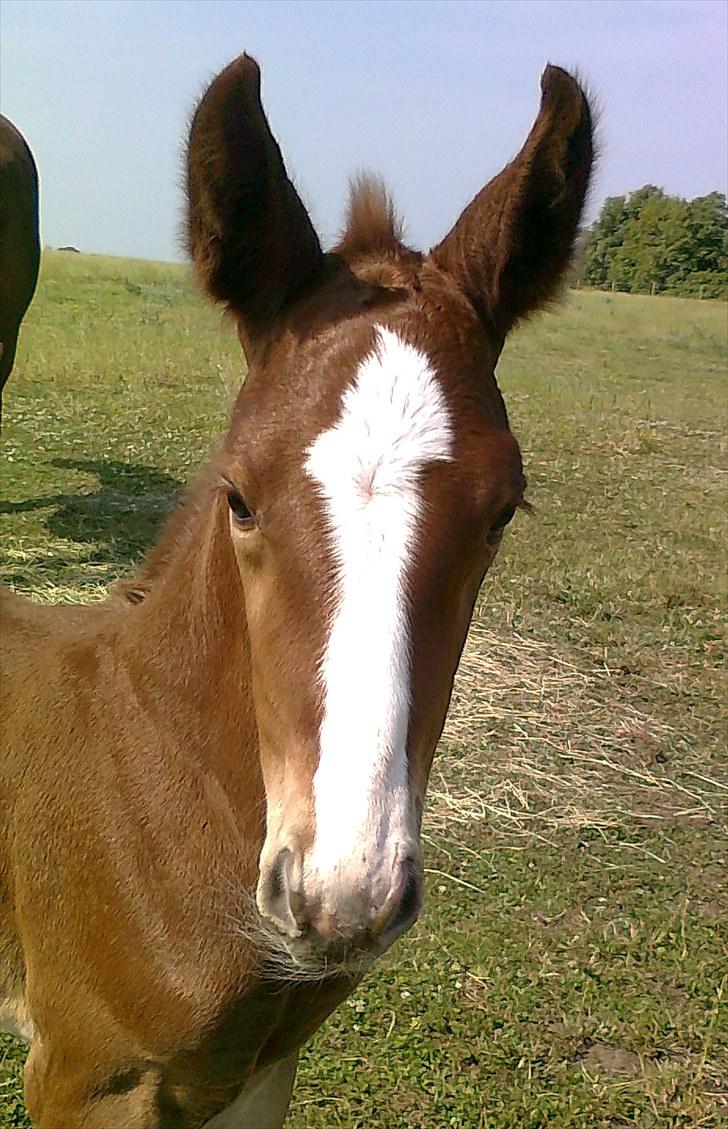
0, 114, 41, 409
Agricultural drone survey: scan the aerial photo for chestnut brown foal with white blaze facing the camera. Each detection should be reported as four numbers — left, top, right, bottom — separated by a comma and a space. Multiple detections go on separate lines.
0, 55, 591, 1129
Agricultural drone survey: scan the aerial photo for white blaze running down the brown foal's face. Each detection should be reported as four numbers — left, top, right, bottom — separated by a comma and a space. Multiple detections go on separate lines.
304, 326, 453, 916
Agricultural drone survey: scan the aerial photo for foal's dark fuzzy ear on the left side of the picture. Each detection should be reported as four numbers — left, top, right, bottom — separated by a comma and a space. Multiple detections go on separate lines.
187, 55, 323, 342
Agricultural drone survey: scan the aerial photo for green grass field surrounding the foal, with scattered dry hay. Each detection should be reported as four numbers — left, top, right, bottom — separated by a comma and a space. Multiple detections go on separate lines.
0, 253, 728, 1129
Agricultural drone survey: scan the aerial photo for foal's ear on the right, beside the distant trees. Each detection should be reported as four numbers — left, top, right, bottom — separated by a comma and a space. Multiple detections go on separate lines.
432, 65, 594, 338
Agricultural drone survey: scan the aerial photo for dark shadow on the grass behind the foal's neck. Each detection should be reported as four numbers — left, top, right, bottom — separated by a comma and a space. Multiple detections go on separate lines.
0, 458, 184, 566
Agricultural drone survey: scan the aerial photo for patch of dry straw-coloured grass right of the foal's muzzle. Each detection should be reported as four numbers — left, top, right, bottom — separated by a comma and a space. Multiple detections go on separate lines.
426, 620, 728, 848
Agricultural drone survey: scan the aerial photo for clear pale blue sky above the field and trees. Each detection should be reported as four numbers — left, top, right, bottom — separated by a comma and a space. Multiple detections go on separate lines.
0, 0, 728, 259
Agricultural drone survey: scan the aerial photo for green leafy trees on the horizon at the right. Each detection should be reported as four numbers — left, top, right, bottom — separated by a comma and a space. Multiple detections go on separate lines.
579, 184, 728, 298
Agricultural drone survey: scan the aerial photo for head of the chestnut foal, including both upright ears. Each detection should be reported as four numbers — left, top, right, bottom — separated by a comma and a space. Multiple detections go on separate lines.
187, 55, 593, 952
